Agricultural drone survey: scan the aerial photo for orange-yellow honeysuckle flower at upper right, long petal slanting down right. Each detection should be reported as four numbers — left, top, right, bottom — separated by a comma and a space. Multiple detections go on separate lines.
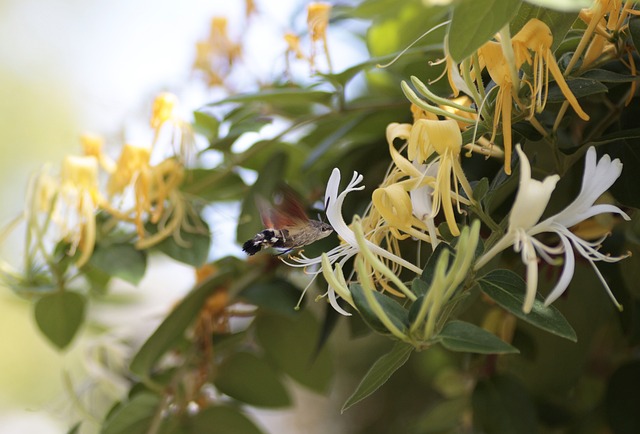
512, 18, 589, 121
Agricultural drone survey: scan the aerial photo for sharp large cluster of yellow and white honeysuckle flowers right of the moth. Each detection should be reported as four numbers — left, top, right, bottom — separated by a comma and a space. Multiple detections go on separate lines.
291, 1, 635, 328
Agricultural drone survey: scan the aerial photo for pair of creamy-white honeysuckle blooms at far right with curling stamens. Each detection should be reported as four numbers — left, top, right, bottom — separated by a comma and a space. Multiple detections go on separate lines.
474, 145, 630, 313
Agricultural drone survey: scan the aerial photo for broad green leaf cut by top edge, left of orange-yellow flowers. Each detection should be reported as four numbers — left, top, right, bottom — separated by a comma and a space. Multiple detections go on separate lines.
448, 0, 522, 62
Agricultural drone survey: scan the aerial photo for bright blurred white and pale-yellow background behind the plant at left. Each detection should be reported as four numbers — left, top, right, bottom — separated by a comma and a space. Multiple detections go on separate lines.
0, 0, 362, 434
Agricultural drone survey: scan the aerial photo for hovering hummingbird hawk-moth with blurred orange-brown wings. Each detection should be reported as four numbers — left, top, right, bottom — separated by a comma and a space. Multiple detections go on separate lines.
242, 190, 333, 255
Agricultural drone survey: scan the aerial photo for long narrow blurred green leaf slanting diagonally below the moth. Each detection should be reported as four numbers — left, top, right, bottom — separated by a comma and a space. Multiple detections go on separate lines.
130, 270, 231, 377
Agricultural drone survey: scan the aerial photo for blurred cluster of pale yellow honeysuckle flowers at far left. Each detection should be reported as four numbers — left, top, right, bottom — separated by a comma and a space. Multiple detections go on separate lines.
25, 93, 193, 268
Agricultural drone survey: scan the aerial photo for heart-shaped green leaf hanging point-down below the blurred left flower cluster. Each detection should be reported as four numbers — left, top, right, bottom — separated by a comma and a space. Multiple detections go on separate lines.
34, 291, 86, 350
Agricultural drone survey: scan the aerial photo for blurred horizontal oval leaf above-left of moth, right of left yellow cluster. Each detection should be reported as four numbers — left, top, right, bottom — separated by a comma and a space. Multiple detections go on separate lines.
180, 168, 249, 202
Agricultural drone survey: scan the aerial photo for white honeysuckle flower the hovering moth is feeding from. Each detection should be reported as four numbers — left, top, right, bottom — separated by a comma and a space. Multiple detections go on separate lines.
285, 168, 422, 315
